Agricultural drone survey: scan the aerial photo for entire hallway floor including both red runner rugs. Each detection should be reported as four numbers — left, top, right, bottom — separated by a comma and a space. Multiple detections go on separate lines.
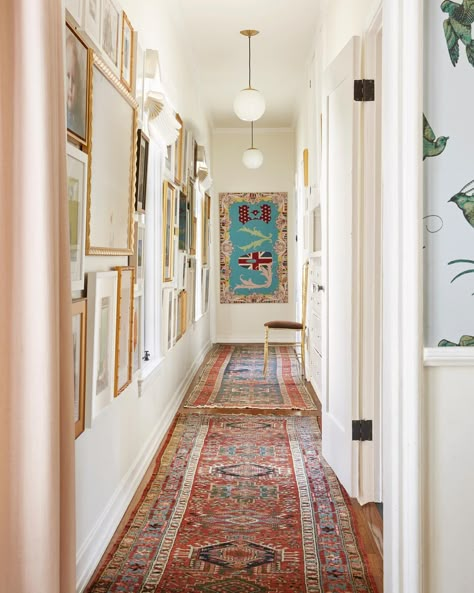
86, 345, 382, 593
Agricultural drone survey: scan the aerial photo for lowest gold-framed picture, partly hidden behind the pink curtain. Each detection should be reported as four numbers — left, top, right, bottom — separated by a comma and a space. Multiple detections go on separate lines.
72, 299, 87, 439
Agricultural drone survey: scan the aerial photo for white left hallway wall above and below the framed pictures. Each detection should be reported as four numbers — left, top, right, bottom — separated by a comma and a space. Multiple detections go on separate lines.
76, 0, 210, 590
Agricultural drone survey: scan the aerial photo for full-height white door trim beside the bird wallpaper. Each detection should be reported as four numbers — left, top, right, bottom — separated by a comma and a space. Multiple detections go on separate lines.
382, 0, 423, 593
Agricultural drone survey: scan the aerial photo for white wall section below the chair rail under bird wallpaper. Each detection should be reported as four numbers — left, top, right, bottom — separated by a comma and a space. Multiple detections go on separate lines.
423, 366, 474, 593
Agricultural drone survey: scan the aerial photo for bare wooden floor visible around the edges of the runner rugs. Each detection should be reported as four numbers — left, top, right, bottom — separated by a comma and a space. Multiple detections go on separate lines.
91, 350, 383, 593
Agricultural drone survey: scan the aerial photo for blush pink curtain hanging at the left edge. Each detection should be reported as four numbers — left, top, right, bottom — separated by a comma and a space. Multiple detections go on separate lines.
0, 0, 75, 593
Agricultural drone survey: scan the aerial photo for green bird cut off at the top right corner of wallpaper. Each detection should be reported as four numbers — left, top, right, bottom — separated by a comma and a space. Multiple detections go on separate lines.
441, 0, 474, 66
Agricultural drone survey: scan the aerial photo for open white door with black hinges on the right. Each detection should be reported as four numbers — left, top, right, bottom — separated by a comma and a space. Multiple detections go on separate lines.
321, 37, 361, 496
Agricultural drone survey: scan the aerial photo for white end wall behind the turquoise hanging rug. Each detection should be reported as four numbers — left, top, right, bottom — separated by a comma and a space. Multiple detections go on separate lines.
212, 128, 296, 342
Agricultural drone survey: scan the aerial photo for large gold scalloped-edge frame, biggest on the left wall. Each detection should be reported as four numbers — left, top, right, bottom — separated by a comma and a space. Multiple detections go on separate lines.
86, 54, 137, 255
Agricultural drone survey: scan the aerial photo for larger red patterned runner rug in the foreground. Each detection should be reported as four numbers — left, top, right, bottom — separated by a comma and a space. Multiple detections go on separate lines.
87, 414, 376, 593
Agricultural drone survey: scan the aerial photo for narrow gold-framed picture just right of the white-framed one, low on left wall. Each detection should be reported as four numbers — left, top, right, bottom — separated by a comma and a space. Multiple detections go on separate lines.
114, 266, 135, 397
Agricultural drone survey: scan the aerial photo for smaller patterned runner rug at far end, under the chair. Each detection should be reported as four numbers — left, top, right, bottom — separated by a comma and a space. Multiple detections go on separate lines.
185, 344, 316, 410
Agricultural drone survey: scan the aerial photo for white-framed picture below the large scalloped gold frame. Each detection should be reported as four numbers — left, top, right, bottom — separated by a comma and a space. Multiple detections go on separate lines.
86, 271, 117, 426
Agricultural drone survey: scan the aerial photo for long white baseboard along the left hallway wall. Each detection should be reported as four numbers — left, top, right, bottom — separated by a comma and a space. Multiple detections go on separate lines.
76, 342, 212, 593
